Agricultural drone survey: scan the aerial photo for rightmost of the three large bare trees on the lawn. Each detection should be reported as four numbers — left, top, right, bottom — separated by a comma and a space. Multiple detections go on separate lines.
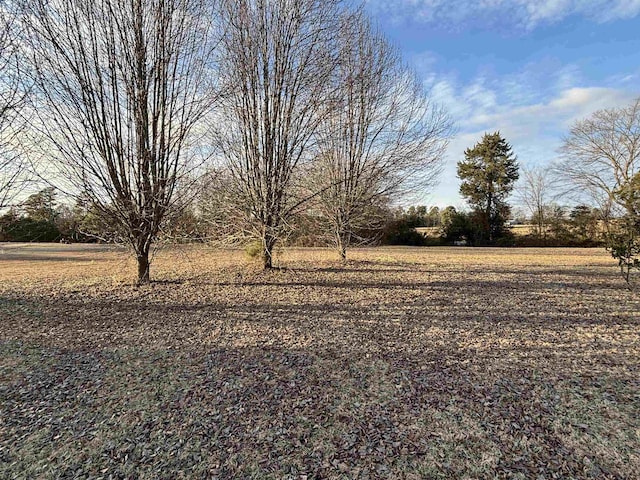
307, 16, 451, 260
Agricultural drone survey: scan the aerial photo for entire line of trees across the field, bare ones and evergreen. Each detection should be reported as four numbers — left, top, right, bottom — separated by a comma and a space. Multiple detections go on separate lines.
0, 0, 640, 283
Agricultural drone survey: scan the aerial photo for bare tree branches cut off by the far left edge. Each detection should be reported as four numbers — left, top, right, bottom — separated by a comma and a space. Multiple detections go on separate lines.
0, 2, 26, 210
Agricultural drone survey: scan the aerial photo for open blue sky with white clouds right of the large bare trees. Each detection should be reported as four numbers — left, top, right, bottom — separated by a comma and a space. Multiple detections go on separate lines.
365, 0, 640, 207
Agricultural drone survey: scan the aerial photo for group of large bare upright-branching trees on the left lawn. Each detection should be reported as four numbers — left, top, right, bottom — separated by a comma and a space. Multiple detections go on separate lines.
0, 0, 451, 283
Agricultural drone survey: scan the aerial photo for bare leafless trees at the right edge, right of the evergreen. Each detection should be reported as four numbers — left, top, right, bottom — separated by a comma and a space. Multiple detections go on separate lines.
504, 98, 640, 281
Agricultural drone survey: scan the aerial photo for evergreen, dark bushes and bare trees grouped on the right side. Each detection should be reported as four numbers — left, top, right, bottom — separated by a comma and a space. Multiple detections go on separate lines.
384, 99, 640, 258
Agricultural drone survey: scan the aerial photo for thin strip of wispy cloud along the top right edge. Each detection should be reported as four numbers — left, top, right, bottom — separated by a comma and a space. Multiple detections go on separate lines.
366, 0, 640, 30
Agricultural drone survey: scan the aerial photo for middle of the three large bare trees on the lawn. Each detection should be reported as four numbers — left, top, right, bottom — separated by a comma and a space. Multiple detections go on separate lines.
216, 0, 340, 268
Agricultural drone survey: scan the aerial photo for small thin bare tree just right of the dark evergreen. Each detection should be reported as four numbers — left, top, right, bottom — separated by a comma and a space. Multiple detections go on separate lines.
518, 167, 557, 238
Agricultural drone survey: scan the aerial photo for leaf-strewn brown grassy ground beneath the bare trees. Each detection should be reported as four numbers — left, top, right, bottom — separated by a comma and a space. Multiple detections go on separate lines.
0, 245, 640, 479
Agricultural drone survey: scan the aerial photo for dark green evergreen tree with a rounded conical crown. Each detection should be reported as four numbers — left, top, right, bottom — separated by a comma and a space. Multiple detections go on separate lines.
458, 132, 519, 243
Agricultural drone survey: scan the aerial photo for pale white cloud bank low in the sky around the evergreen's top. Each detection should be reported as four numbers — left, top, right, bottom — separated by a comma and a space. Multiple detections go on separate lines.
425, 59, 638, 206
